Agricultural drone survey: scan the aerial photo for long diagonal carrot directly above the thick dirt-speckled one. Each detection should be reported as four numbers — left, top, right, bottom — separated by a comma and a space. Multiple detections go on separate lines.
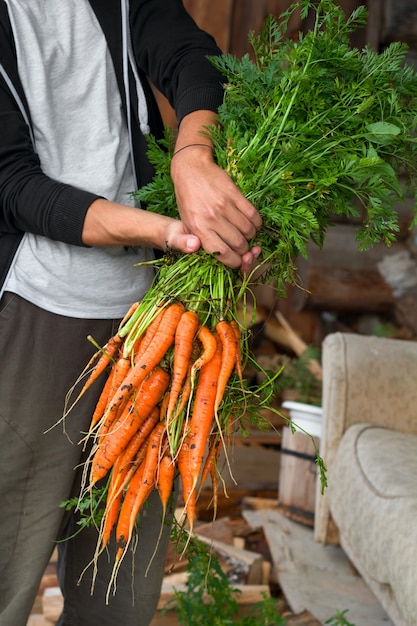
100, 302, 184, 428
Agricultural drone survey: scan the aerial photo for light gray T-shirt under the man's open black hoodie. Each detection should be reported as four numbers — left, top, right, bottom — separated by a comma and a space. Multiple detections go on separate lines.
6, 0, 153, 318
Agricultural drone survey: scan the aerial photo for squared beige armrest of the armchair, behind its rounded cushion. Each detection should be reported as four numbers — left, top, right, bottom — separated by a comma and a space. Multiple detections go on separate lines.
314, 333, 417, 543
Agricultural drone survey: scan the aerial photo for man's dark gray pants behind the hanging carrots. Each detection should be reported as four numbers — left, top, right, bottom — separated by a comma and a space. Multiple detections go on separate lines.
0, 293, 169, 626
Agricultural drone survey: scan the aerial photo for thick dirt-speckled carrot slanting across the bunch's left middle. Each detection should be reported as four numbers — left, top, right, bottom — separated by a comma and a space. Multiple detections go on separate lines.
90, 366, 170, 485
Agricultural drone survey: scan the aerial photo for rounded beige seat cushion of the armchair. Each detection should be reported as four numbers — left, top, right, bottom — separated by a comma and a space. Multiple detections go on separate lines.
328, 423, 417, 626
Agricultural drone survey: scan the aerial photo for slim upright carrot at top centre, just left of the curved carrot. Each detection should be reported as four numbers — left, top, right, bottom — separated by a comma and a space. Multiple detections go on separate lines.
166, 311, 200, 422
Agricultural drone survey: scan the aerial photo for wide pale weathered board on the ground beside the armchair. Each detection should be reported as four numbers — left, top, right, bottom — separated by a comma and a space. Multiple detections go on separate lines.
242, 509, 394, 626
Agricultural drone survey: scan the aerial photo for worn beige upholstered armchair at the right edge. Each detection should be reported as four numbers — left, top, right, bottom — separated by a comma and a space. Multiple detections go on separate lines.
315, 333, 417, 626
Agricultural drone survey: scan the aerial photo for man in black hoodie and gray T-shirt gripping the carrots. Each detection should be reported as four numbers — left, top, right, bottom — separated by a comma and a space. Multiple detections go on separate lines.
0, 0, 261, 626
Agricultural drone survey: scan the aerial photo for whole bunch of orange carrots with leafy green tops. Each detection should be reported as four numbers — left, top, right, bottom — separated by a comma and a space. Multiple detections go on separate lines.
65, 0, 417, 588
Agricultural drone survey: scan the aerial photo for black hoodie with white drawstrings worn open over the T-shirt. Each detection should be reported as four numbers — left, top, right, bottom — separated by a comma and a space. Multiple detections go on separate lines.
0, 0, 223, 285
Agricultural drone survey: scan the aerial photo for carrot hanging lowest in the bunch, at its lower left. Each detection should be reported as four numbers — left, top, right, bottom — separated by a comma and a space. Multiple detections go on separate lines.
116, 422, 165, 558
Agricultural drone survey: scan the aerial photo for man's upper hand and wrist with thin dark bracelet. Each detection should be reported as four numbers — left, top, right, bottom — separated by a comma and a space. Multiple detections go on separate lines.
171, 111, 262, 273
